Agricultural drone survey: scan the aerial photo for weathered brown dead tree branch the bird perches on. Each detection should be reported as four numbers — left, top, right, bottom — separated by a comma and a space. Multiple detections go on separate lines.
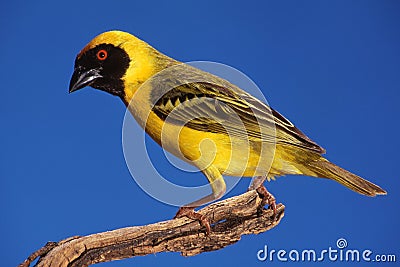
19, 190, 285, 267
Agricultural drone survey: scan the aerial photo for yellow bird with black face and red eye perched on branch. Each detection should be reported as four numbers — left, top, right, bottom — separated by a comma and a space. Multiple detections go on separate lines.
69, 30, 386, 233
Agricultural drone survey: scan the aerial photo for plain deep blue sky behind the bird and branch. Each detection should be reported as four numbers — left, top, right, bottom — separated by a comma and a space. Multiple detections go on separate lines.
0, 1, 400, 266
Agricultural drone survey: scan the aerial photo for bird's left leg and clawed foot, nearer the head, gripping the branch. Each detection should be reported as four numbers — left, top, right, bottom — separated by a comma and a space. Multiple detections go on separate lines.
174, 166, 226, 235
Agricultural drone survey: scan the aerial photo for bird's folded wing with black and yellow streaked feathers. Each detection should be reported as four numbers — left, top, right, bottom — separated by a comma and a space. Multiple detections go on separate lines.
148, 63, 325, 153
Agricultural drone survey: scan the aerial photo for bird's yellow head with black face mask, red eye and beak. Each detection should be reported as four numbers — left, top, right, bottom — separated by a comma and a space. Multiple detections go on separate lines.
69, 31, 167, 101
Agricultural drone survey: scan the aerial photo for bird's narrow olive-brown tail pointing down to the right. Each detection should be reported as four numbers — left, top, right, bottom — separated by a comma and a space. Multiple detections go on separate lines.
307, 160, 386, 197
